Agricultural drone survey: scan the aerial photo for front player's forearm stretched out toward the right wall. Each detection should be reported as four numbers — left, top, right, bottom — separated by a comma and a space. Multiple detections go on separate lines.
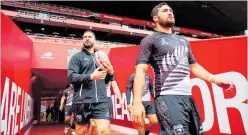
190, 63, 215, 82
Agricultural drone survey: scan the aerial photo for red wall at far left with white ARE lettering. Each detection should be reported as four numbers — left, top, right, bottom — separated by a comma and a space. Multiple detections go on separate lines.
0, 13, 33, 135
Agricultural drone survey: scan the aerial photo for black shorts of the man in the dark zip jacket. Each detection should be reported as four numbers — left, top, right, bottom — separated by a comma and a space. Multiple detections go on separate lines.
74, 102, 111, 125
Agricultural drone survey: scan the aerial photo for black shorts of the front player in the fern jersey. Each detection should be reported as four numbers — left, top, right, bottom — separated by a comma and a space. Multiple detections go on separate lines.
155, 95, 203, 135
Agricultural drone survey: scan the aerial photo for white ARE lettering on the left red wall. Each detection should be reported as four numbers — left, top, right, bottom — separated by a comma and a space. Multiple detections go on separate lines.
0, 77, 33, 134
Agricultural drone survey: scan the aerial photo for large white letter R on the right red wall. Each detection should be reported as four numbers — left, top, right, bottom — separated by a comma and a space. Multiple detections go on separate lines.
212, 72, 248, 134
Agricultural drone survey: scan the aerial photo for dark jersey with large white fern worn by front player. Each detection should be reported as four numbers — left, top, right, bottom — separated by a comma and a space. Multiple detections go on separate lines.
136, 32, 196, 96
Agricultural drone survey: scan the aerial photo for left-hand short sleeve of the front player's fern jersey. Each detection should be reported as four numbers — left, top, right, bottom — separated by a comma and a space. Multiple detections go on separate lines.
136, 36, 152, 64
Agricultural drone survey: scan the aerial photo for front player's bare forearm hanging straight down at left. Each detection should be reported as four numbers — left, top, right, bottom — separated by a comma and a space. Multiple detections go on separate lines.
133, 69, 145, 103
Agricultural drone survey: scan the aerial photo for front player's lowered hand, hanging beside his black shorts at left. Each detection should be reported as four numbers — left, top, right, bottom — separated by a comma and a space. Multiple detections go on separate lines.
132, 101, 146, 125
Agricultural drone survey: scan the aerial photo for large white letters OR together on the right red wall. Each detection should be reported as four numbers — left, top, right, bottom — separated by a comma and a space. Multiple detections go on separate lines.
191, 72, 248, 134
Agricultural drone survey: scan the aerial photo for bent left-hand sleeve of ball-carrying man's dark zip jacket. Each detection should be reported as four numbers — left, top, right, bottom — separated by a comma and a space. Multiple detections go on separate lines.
68, 55, 91, 84
